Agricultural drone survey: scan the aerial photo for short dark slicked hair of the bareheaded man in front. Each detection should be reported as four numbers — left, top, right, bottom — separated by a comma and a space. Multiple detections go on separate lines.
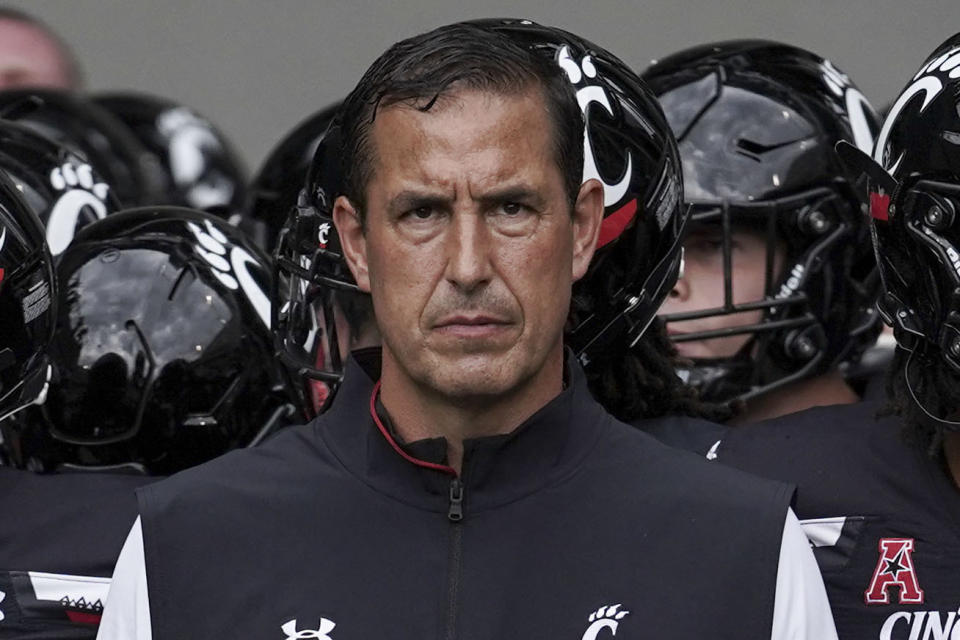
340, 23, 584, 219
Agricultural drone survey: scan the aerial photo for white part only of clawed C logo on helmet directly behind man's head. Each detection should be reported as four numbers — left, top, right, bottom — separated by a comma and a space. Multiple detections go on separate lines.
557, 45, 633, 207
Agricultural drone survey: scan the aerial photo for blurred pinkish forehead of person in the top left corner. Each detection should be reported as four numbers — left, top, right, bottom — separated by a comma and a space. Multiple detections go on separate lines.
0, 19, 73, 90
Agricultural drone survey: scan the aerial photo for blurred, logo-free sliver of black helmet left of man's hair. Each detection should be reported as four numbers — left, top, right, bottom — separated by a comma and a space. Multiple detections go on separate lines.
248, 103, 340, 253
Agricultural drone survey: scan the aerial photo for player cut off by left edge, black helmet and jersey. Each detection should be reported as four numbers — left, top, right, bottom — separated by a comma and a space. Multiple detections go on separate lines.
0, 171, 149, 640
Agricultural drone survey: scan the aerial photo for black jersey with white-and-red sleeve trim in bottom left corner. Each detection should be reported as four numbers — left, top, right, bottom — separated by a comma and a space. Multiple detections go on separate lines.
0, 467, 151, 640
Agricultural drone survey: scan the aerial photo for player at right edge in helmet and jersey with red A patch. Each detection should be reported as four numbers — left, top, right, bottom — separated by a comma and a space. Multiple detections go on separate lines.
708, 34, 960, 640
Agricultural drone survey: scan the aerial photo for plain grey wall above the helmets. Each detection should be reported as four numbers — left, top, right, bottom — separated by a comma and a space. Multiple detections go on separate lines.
9, 0, 960, 170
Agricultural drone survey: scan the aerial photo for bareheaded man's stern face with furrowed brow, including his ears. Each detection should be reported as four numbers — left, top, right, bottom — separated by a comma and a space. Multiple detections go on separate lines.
335, 91, 603, 399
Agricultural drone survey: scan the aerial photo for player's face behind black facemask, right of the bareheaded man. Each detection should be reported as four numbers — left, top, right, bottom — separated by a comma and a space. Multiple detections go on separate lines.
660, 224, 783, 359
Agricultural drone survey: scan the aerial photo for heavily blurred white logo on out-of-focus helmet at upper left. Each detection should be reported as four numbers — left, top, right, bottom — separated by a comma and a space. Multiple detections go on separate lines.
157, 107, 233, 209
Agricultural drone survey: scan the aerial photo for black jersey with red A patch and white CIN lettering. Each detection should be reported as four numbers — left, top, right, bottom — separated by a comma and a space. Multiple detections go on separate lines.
714, 402, 960, 640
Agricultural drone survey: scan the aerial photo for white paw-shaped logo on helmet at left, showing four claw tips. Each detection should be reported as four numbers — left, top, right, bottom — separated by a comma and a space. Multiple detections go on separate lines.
47, 162, 110, 256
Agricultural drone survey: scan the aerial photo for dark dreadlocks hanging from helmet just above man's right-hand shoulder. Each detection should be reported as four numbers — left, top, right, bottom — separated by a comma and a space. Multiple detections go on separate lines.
586, 318, 734, 422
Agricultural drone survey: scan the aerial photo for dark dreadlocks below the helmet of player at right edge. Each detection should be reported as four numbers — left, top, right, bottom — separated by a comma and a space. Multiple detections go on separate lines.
882, 343, 960, 457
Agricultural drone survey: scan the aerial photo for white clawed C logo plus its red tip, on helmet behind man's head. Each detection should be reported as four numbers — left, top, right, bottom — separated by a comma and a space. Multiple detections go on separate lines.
557, 45, 637, 249
